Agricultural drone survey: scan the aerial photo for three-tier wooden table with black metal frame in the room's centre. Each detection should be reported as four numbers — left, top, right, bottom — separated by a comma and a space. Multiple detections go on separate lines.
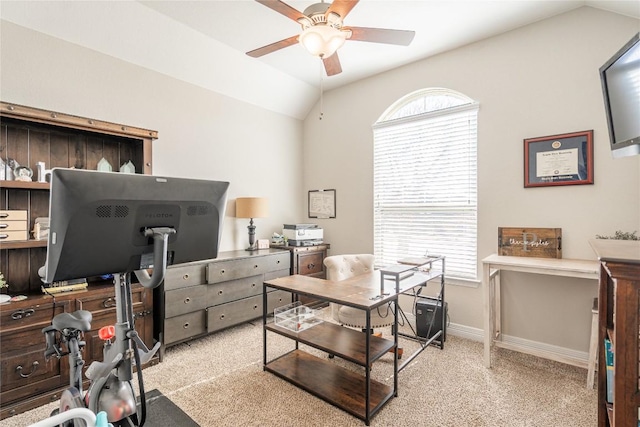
263, 271, 434, 425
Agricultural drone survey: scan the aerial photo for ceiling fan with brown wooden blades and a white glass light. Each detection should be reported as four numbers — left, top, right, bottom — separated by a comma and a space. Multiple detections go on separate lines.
247, 0, 415, 76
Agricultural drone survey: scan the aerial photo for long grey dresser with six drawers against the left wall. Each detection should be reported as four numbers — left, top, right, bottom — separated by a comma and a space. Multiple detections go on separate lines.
155, 249, 291, 357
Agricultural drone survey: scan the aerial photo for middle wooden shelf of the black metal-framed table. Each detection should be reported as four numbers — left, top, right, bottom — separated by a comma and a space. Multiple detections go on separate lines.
265, 322, 394, 366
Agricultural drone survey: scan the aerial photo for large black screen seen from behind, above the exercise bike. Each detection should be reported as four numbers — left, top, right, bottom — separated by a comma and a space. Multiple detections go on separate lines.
44, 169, 229, 283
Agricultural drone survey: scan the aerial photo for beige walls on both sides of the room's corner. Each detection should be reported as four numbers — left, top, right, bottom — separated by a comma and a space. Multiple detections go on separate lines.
0, 8, 640, 362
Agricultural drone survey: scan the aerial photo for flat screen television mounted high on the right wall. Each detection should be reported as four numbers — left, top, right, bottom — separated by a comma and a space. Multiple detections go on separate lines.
600, 33, 640, 158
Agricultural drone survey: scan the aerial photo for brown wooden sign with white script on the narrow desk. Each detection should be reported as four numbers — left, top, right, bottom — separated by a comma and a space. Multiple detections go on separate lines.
498, 227, 562, 258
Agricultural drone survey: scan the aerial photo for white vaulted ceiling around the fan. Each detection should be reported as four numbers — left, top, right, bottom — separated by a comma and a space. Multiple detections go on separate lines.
0, 0, 640, 118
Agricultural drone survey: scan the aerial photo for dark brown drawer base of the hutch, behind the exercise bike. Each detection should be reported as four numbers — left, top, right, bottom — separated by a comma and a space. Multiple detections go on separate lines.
0, 285, 157, 419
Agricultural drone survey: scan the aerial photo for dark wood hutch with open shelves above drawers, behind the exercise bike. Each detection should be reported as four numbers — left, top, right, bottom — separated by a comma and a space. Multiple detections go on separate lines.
0, 101, 158, 419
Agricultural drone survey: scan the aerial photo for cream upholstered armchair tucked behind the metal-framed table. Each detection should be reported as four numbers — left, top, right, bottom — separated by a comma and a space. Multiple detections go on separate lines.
324, 254, 394, 330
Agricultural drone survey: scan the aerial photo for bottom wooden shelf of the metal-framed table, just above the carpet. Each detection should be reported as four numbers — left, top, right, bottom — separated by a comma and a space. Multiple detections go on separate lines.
265, 350, 393, 420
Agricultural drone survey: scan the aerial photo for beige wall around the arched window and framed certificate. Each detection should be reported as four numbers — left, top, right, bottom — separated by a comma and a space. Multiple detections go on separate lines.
304, 7, 640, 352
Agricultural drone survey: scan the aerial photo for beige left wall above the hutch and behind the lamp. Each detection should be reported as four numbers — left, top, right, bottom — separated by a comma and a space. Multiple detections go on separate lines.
0, 21, 303, 250
